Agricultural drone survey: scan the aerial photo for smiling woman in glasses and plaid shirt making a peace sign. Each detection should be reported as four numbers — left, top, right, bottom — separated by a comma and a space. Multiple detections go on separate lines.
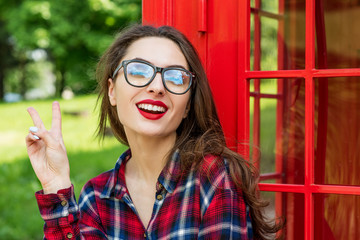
26, 23, 281, 239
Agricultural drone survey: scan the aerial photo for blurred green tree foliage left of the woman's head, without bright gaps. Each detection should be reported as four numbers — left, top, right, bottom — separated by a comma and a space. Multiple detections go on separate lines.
0, 0, 141, 99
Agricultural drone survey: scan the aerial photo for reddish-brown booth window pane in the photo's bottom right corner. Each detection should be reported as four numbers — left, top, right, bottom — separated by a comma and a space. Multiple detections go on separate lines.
314, 194, 360, 240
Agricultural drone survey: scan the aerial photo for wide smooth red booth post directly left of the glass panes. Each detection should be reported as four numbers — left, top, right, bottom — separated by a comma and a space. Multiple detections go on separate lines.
207, 1, 240, 148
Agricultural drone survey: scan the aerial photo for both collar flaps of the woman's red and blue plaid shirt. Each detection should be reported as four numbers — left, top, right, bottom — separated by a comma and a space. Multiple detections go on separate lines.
100, 149, 181, 199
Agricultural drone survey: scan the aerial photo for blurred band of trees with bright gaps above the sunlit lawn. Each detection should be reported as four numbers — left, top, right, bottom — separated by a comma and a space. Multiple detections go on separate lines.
0, 0, 141, 102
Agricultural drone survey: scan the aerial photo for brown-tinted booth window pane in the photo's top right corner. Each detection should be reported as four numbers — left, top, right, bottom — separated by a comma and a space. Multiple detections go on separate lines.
315, 0, 360, 69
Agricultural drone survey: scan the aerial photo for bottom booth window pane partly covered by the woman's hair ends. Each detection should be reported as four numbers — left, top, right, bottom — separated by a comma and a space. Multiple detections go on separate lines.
261, 191, 305, 240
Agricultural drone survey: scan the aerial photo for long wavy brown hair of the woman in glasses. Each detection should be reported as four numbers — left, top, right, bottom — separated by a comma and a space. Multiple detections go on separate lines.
97, 25, 283, 239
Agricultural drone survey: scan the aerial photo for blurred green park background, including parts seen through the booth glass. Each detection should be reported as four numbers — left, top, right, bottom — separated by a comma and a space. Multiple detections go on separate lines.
0, 0, 277, 240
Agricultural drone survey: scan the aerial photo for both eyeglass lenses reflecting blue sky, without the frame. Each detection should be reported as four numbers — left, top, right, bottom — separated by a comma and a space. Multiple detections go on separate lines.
126, 62, 191, 93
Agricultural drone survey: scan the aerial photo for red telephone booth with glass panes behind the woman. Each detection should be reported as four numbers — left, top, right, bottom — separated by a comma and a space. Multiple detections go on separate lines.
143, 0, 360, 240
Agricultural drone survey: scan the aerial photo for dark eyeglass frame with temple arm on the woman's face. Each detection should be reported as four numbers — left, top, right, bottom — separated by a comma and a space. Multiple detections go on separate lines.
112, 59, 196, 95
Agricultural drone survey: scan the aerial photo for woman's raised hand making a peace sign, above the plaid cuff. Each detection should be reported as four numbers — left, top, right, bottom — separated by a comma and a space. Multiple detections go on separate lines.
26, 102, 71, 194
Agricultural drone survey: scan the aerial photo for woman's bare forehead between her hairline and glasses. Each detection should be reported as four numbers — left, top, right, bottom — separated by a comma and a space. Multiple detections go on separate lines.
123, 37, 188, 67
